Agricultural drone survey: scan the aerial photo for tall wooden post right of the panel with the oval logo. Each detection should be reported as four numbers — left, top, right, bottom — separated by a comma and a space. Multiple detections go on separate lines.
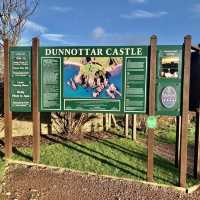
179, 35, 192, 187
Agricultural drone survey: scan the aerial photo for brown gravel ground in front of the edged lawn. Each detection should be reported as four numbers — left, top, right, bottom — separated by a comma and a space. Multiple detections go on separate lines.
0, 164, 200, 200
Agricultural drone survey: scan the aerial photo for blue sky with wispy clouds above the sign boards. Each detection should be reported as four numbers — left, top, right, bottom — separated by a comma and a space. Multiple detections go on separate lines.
20, 0, 200, 46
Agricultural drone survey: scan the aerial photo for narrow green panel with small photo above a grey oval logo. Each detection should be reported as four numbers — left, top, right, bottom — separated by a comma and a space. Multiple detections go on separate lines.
156, 45, 183, 116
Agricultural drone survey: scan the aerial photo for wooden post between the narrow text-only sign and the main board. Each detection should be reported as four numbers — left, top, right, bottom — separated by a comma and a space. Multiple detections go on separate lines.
32, 38, 40, 163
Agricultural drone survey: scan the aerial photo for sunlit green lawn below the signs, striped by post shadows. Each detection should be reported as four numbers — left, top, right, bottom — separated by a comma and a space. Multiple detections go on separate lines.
13, 138, 197, 186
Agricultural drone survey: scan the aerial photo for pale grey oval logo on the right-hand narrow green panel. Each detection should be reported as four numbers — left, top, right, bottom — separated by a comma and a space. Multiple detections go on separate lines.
161, 86, 177, 108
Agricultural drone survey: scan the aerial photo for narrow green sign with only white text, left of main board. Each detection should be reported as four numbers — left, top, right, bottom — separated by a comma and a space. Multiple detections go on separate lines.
10, 47, 32, 112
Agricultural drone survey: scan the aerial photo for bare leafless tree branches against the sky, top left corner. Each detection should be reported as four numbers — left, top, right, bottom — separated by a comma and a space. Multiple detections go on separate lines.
0, 0, 39, 47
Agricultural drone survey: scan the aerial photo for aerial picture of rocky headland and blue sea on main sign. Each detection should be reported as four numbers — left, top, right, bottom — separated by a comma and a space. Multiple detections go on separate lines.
63, 56, 123, 99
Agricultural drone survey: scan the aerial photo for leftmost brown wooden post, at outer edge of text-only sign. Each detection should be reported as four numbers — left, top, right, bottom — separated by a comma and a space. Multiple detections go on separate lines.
4, 39, 12, 159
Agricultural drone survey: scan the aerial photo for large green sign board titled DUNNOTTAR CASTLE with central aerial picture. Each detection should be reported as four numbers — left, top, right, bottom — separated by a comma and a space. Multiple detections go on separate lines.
39, 46, 148, 113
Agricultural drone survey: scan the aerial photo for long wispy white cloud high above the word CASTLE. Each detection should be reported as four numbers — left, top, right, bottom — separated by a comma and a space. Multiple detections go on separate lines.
120, 10, 168, 19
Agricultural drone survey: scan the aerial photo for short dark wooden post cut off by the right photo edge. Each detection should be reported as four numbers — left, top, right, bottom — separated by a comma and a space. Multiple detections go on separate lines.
194, 108, 200, 179
